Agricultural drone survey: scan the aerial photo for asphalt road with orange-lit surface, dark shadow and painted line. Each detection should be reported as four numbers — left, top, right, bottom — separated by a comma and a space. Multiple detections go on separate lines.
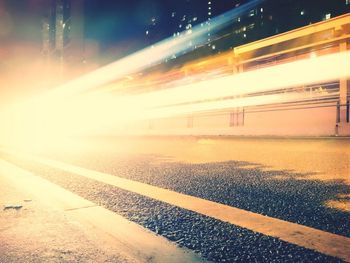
0, 137, 350, 262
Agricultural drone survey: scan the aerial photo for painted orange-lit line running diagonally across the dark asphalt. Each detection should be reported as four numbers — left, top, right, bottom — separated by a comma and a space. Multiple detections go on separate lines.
21, 156, 350, 262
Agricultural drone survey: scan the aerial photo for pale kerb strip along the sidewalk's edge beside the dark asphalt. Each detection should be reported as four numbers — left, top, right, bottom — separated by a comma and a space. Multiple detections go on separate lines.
0, 159, 203, 263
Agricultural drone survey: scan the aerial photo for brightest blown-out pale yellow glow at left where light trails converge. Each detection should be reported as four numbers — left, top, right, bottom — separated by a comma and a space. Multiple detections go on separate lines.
0, 91, 147, 151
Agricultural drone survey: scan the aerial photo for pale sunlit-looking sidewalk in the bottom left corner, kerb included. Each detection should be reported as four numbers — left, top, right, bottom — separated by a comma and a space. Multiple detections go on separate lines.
0, 160, 202, 262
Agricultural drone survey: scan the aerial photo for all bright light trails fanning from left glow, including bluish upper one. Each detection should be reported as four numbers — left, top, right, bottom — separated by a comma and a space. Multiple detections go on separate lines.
0, 0, 350, 152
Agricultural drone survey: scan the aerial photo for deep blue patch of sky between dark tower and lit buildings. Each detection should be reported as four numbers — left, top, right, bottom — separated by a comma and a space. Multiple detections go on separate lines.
85, 0, 244, 47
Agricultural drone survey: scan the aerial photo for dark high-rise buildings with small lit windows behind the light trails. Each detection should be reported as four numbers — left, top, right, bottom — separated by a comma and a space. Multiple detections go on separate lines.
145, 0, 350, 62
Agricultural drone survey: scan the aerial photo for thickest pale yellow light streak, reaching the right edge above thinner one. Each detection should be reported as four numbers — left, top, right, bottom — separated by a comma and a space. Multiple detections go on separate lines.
133, 51, 350, 107
